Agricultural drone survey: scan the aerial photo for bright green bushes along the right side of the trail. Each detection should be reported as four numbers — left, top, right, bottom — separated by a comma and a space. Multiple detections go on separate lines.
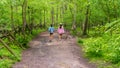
78, 19, 120, 68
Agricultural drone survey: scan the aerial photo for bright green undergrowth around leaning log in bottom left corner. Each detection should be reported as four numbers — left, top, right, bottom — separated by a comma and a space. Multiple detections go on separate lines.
0, 45, 22, 68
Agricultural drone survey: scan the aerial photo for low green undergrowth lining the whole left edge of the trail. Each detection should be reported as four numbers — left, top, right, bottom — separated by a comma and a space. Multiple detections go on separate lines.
0, 29, 44, 68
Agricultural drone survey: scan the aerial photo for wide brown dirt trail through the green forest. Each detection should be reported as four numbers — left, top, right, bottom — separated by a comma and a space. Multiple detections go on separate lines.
13, 32, 96, 68
